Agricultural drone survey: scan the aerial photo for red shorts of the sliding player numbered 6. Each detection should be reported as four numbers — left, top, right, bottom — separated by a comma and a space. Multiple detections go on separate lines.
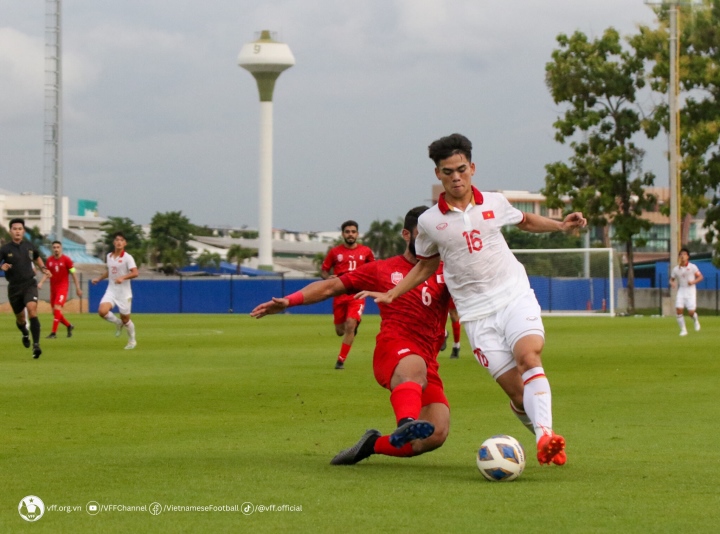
373, 336, 450, 407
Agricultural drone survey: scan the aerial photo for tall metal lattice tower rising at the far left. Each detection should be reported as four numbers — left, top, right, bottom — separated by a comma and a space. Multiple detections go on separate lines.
43, 0, 63, 240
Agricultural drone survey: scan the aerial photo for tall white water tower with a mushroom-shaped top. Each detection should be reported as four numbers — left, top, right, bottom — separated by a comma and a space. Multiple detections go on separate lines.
238, 30, 295, 271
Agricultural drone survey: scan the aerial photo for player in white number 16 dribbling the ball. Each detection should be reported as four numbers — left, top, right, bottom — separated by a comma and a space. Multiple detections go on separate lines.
360, 134, 587, 465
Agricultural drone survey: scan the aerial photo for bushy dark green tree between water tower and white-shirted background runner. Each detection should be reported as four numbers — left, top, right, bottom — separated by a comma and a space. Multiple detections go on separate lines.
150, 211, 195, 273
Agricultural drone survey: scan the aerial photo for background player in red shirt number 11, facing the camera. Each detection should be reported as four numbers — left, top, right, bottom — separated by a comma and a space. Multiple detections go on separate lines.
320, 221, 375, 369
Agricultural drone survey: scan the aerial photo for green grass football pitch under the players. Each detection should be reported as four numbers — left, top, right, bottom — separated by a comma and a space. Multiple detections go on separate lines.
0, 314, 720, 533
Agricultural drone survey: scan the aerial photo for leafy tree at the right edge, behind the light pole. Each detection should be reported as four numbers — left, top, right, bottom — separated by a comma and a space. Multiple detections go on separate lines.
630, 0, 720, 265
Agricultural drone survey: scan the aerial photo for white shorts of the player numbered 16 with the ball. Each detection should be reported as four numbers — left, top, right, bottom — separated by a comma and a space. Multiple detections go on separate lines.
463, 289, 545, 380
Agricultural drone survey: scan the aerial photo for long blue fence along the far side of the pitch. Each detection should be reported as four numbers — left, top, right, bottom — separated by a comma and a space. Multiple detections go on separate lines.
87, 276, 620, 314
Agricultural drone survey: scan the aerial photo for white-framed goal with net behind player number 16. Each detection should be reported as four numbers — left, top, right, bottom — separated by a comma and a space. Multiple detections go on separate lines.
512, 248, 622, 317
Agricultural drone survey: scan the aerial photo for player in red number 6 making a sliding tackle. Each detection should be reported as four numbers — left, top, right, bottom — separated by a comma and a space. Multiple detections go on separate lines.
250, 206, 450, 465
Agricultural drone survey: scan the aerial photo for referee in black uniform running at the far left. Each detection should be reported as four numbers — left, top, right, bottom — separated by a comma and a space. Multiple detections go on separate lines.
0, 219, 50, 358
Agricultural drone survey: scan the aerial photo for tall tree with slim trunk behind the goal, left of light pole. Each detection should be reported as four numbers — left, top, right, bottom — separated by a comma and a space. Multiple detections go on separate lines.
543, 28, 659, 313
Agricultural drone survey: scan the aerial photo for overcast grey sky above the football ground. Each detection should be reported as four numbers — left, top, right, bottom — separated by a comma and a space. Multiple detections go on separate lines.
0, 0, 668, 232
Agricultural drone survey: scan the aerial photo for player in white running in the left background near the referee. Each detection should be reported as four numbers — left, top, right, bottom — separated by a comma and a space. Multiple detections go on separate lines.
92, 232, 138, 350
